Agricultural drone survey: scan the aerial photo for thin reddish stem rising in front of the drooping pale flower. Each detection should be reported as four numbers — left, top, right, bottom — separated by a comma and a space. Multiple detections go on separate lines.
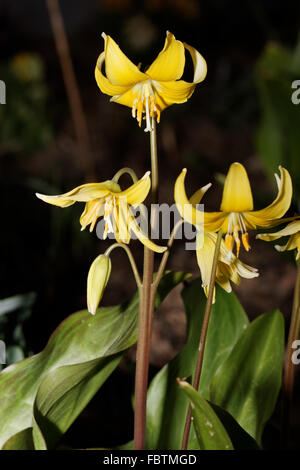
181, 230, 222, 450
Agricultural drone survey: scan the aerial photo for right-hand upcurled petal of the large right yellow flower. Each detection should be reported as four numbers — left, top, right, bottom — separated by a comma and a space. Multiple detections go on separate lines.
246, 166, 293, 227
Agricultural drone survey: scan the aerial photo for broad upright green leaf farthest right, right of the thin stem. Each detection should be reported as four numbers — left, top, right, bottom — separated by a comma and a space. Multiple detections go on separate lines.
211, 310, 284, 444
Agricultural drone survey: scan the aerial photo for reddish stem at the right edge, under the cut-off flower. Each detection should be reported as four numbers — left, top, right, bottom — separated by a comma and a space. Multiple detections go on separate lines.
281, 262, 300, 448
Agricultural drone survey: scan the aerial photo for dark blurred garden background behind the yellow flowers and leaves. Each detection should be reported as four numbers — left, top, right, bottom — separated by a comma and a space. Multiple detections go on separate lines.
0, 0, 300, 448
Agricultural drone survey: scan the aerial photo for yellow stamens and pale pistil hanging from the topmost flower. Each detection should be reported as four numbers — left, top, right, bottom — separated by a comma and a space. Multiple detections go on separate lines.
132, 81, 160, 132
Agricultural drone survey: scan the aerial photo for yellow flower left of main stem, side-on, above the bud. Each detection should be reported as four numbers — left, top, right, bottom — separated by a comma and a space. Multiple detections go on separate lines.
36, 172, 166, 253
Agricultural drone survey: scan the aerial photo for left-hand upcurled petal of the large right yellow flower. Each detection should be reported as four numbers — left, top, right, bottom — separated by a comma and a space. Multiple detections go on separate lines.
174, 168, 226, 232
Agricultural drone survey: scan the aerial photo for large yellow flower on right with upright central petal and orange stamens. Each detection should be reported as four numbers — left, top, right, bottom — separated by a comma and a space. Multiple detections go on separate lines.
175, 163, 293, 256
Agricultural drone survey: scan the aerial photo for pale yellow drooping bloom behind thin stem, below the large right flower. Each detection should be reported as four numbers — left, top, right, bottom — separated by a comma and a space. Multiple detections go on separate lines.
196, 232, 259, 301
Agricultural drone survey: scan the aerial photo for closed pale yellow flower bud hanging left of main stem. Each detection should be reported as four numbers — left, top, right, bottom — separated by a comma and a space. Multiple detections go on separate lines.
87, 255, 111, 315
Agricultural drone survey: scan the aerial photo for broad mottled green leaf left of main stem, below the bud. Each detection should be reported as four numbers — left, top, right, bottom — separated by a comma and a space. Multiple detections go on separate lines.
0, 273, 186, 448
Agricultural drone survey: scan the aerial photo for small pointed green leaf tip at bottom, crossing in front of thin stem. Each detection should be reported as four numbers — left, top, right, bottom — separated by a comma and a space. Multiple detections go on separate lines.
179, 381, 233, 450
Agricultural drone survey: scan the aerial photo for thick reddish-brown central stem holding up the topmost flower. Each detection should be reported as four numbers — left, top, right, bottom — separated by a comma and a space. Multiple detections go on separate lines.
134, 118, 158, 450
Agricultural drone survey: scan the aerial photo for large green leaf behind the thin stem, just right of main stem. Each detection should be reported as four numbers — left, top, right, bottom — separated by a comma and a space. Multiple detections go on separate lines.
146, 279, 249, 449
